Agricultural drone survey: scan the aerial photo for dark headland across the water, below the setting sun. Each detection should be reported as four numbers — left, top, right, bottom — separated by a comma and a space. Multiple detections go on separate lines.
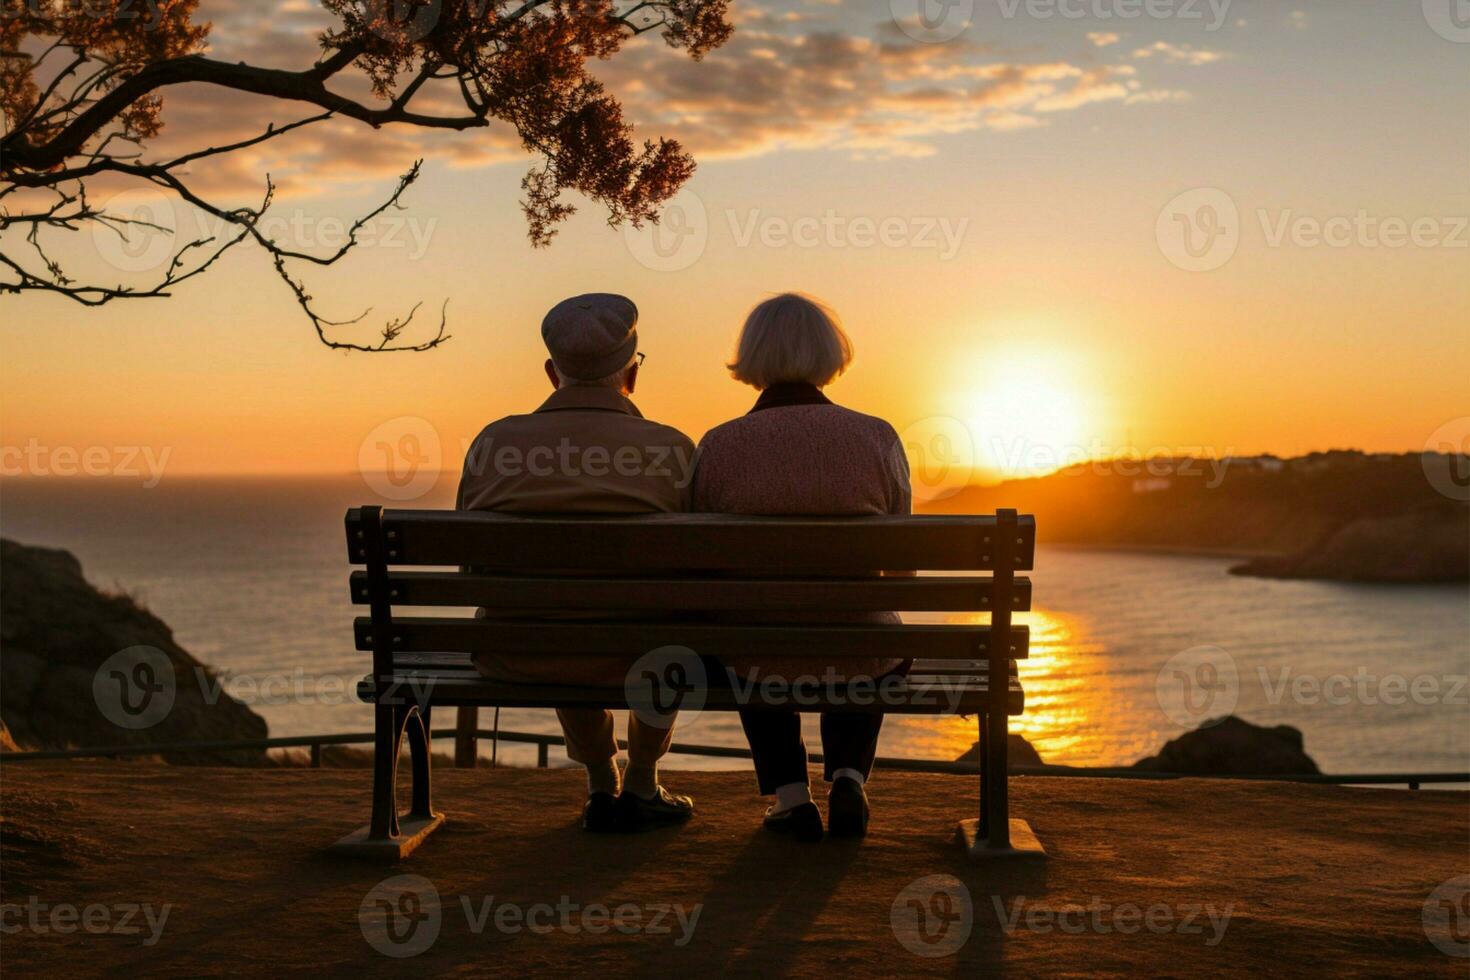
922, 450, 1470, 582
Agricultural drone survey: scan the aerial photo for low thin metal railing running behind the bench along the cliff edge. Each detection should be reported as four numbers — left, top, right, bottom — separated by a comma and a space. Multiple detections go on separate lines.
0, 729, 1470, 789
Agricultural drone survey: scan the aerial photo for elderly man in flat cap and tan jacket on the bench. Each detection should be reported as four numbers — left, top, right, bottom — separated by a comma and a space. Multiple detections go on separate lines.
457, 292, 694, 832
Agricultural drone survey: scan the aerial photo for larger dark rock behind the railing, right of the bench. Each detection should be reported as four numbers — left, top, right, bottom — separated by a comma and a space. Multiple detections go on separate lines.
1133, 714, 1322, 776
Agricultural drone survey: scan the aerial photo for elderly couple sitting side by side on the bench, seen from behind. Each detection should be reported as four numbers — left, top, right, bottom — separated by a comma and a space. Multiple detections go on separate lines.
457, 294, 911, 842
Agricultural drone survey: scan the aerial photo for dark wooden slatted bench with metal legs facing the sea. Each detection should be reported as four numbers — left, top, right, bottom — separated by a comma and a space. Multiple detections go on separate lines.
335, 507, 1041, 860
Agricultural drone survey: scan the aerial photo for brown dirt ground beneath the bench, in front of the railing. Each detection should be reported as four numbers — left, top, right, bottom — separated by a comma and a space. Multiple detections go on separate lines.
0, 763, 1470, 979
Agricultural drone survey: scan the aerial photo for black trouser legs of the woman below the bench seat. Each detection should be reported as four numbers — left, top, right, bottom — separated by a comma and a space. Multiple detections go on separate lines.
739, 708, 883, 796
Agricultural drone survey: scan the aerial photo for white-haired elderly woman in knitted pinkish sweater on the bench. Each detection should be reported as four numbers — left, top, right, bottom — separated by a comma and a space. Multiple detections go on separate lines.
694, 292, 911, 840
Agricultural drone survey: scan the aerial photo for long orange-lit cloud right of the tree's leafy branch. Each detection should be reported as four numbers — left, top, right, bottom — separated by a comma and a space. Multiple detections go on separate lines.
600, 25, 1211, 159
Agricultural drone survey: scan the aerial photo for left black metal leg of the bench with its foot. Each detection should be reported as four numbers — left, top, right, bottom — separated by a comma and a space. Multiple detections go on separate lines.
331, 704, 444, 861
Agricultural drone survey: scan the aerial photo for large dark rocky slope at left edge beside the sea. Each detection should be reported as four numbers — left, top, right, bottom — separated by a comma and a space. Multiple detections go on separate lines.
0, 539, 266, 765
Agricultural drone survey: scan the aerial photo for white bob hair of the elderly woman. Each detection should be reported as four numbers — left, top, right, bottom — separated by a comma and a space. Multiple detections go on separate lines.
726, 292, 853, 391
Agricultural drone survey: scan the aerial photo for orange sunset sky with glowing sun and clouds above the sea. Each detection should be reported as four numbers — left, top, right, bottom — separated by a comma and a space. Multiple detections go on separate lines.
0, 0, 1470, 476
